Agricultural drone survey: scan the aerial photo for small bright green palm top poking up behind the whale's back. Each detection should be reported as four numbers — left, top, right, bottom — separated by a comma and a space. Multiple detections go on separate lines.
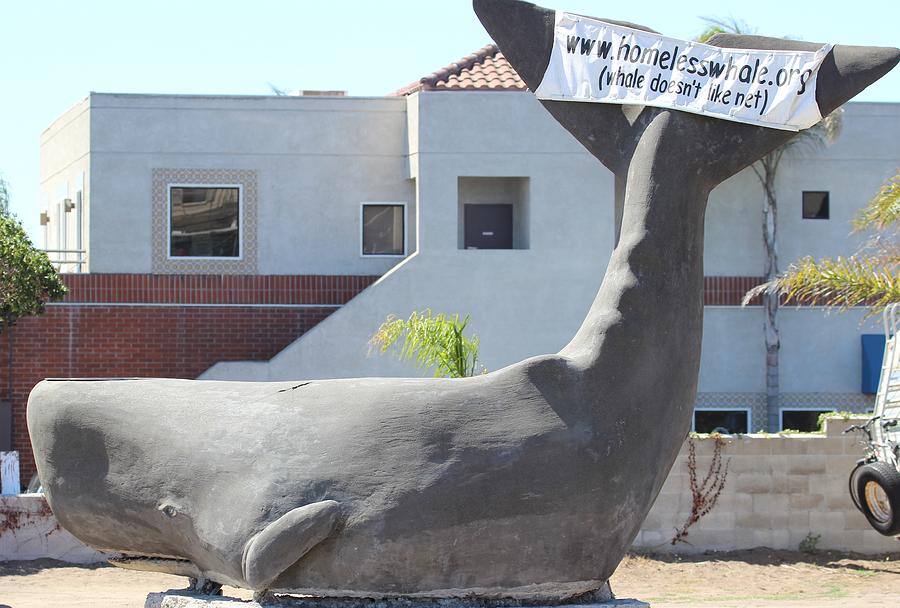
369, 309, 478, 378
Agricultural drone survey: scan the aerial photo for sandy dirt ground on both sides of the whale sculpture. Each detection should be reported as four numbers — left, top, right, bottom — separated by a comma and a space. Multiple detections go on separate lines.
0, 549, 900, 608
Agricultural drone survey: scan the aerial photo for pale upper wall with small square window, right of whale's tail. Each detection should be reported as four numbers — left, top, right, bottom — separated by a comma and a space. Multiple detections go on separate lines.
704, 103, 900, 276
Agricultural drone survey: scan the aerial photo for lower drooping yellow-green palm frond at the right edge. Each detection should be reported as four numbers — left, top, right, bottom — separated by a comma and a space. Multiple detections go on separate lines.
742, 256, 900, 316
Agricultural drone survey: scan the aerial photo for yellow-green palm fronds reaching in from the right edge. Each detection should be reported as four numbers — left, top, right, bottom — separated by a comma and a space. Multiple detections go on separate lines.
744, 173, 900, 316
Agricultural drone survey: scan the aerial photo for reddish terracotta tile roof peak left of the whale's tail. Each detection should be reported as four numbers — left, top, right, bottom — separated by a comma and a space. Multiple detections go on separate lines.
391, 44, 527, 96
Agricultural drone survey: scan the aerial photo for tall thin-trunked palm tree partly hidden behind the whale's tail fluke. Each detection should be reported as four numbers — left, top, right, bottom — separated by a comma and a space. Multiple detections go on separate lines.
697, 17, 844, 431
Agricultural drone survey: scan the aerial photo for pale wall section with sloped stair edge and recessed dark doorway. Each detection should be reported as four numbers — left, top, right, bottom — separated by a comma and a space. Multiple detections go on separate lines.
201, 92, 613, 380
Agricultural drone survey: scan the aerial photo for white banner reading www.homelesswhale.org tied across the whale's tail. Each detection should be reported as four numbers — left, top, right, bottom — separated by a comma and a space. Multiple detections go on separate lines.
535, 11, 831, 131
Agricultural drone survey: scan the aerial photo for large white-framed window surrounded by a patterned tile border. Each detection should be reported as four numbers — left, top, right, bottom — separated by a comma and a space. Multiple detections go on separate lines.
169, 186, 241, 258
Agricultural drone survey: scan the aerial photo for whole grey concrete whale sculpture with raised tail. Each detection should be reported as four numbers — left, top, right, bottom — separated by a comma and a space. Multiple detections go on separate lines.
28, 0, 900, 601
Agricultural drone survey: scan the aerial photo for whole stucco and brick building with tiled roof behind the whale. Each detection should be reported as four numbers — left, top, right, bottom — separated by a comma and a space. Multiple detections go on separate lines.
7, 47, 900, 482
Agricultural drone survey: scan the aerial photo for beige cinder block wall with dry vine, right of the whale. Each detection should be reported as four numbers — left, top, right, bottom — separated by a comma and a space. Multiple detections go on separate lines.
634, 419, 900, 553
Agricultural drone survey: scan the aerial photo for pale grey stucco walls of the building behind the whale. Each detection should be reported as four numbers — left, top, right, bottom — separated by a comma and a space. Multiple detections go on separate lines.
41, 91, 900, 430
